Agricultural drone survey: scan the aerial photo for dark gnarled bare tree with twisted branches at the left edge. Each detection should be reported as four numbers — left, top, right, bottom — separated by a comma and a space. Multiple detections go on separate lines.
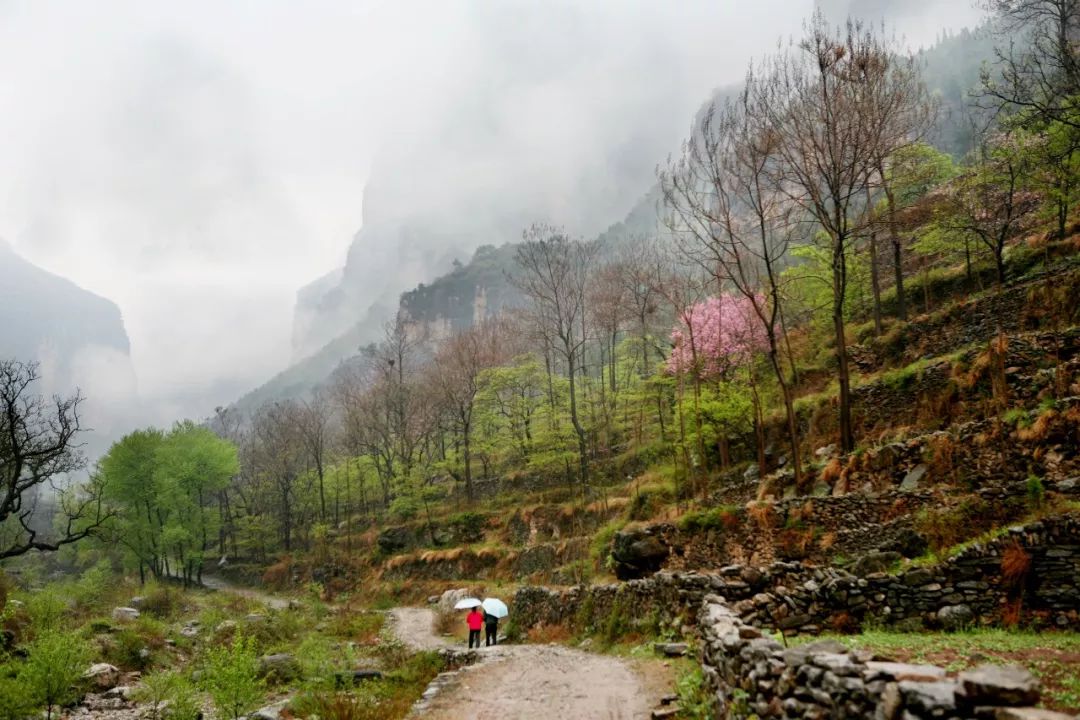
0, 359, 109, 559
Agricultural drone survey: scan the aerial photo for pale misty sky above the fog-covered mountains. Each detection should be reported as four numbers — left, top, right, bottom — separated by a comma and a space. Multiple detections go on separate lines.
0, 0, 984, 422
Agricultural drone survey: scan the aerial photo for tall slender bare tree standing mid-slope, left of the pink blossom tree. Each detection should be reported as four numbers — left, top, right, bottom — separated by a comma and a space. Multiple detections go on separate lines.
511, 225, 596, 489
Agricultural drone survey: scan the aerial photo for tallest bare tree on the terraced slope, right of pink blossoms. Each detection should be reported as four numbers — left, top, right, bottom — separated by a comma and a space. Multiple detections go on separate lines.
752, 14, 909, 452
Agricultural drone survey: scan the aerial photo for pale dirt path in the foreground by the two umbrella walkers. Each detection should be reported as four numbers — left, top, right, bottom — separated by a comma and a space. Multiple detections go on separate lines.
391, 608, 659, 720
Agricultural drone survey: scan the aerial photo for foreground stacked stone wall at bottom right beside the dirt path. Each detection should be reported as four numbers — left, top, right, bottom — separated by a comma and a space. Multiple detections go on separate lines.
699, 595, 1071, 720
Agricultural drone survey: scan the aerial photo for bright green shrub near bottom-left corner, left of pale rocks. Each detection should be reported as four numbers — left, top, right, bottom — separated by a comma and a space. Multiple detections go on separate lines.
18, 629, 91, 718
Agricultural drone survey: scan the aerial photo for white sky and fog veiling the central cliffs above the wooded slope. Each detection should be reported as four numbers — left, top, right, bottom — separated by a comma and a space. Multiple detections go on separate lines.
0, 0, 989, 451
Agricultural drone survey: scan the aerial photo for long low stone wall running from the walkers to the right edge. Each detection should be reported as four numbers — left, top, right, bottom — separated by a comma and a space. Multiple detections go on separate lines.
514, 515, 1080, 635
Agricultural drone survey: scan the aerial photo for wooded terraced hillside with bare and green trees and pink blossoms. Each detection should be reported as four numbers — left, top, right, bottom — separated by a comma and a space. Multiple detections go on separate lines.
0, 5, 1080, 717
